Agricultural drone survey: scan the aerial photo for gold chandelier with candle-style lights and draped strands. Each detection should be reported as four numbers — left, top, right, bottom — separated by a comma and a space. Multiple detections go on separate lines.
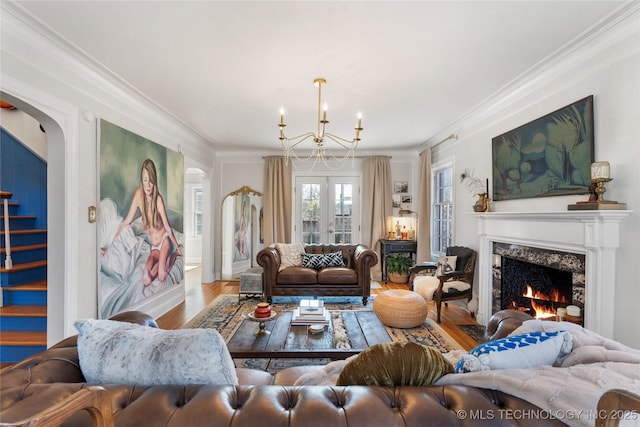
278, 78, 362, 168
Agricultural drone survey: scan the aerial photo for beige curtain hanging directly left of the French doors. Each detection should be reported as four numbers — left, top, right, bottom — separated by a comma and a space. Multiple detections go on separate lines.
263, 157, 293, 246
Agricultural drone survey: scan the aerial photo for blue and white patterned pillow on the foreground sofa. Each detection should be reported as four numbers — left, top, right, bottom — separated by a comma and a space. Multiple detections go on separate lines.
455, 331, 572, 374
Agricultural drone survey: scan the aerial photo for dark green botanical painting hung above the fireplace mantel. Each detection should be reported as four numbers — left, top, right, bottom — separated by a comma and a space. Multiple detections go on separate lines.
492, 95, 594, 201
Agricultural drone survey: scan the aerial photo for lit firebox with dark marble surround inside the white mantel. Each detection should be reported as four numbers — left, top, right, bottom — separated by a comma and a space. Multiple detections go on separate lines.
492, 242, 585, 325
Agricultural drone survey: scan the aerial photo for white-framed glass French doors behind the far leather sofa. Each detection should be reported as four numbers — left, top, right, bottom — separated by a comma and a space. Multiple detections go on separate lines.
293, 176, 360, 244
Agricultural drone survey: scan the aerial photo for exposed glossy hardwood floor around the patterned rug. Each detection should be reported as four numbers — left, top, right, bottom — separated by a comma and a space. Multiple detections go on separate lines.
157, 267, 478, 350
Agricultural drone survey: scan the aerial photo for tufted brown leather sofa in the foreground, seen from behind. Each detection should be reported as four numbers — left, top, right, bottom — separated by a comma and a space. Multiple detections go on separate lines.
0, 311, 576, 427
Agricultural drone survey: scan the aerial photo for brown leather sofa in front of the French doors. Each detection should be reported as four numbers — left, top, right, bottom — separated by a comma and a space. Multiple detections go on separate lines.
257, 245, 378, 305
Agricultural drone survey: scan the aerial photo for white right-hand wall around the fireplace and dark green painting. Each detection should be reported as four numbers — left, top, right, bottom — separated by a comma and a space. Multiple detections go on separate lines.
433, 8, 640, 348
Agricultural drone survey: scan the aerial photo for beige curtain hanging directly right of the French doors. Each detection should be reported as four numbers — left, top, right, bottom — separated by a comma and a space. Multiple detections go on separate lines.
362, 156, 393, 280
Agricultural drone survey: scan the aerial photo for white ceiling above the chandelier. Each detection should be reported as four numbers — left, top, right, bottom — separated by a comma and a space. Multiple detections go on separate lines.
18, 0, 625, 151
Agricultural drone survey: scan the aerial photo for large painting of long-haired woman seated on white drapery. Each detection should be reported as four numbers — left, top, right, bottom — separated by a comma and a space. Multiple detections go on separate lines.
98, 120, 185, 318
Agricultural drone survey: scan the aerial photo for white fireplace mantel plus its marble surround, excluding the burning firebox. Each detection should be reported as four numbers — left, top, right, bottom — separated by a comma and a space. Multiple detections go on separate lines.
471, 210, 630, 338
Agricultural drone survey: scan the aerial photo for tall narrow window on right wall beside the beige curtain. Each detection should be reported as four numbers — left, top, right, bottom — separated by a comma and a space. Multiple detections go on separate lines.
431, 164, 453, 254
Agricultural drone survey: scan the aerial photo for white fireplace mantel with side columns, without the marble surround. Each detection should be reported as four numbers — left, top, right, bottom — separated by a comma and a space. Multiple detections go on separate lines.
473, 210, 633, 338
